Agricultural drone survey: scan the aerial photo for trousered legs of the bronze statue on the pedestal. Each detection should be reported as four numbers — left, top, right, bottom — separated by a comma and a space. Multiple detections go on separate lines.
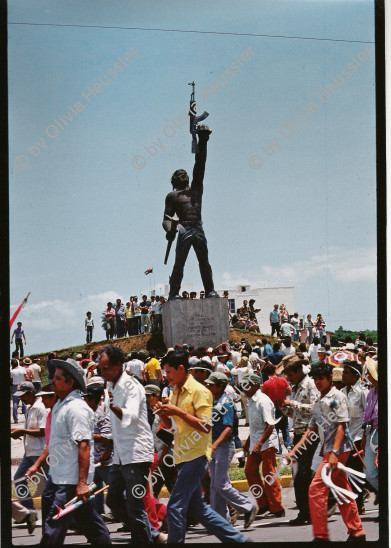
170, 222, 214, 297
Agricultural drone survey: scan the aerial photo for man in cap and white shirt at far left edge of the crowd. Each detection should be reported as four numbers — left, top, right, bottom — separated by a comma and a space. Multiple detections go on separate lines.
11, 381, 47, 510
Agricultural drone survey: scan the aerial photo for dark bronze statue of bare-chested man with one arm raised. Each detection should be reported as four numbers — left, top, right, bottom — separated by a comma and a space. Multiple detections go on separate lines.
163, 126, 219, 301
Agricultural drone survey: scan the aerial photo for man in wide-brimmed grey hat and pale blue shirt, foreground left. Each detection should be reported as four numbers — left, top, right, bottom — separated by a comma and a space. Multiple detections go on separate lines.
41, 359, 111, 546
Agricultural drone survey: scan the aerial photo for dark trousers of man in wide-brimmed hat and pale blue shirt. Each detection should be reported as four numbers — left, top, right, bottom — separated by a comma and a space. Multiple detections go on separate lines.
41, 484, 111, 546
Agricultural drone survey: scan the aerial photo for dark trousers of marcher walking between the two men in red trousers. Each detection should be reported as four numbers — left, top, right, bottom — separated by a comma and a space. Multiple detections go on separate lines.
293, 434, 319, 519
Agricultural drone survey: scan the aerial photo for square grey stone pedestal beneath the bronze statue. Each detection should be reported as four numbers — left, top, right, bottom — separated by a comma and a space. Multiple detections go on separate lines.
162, 298, 229, 348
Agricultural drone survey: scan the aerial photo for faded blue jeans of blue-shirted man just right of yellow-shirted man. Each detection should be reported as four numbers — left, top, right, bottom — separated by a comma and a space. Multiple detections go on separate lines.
209, 441, 253, 522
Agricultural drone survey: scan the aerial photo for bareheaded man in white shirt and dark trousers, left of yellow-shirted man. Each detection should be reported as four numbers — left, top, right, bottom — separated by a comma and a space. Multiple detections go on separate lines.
99, 346, 154, 544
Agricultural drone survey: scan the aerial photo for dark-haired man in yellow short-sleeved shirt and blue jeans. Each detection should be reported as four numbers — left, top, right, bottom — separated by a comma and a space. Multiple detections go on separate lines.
154, 350, 249, 543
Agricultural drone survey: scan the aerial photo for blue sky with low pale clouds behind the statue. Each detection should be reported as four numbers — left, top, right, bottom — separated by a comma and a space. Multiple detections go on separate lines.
8, 0, 377, 352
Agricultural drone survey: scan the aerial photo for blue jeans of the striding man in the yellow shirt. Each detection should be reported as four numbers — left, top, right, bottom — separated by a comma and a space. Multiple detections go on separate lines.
167, 456, 248, 543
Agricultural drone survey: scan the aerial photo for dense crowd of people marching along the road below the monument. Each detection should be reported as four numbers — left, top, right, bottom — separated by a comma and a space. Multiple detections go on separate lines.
11, 330, 378, 545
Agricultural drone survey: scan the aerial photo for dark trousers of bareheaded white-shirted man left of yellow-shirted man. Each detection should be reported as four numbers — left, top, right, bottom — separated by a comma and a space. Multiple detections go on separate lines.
106, 462, 152, 544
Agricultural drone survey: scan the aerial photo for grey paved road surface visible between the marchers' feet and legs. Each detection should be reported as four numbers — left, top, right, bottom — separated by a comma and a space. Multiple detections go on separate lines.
13, 487, 379, 546
